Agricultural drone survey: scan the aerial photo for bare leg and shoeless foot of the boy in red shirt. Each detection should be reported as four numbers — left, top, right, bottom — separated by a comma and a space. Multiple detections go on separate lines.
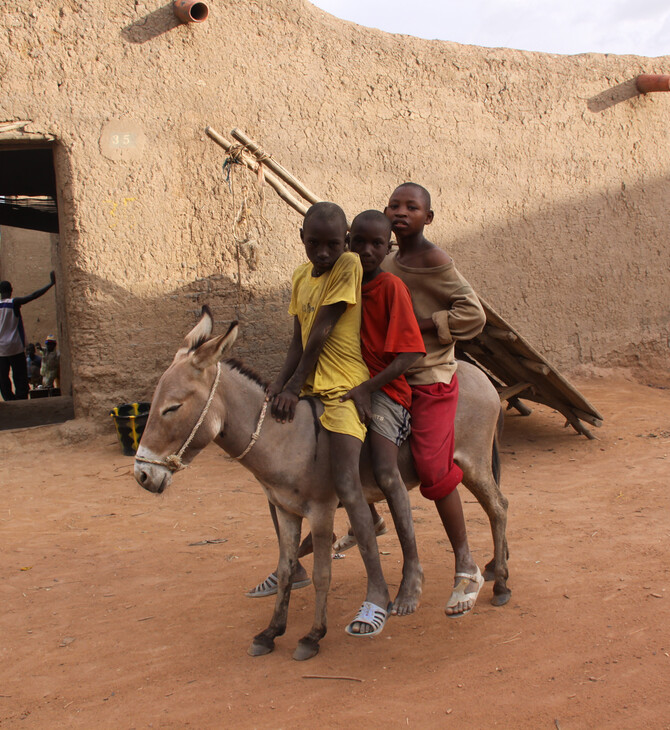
369, 430, 423, 616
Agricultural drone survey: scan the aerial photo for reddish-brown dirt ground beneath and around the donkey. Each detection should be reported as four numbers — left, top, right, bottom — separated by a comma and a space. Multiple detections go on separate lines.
0, 373, 670, 730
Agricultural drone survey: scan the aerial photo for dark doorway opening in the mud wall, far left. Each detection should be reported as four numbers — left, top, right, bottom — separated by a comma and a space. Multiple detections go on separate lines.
0, 134, 74, 430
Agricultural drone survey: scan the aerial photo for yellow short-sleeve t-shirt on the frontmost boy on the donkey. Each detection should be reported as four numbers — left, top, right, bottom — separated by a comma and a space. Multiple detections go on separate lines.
288, 251, 370, 399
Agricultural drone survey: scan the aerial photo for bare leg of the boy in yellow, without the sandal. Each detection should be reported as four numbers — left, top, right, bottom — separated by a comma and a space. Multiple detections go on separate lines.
328, 431, 389, 634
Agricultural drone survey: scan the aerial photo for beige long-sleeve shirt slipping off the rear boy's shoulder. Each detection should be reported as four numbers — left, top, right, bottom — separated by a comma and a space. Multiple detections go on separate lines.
382, 253, 486, 385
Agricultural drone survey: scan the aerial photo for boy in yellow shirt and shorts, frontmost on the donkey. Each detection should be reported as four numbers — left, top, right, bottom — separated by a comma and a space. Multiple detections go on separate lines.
268, 202, 391, 636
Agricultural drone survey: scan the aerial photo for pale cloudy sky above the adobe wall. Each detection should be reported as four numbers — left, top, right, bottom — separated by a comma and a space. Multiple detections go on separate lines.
311, 0, 670, 56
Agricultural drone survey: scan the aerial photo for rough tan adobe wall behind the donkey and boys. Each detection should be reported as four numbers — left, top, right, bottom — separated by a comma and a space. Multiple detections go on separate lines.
0, 0, 670, 414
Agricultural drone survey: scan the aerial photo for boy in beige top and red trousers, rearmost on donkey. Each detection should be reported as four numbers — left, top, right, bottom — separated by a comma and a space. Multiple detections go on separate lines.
383, 183, 486, 617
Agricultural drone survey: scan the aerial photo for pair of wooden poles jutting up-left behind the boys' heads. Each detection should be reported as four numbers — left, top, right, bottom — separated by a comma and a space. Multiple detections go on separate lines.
205, 127, 322, 216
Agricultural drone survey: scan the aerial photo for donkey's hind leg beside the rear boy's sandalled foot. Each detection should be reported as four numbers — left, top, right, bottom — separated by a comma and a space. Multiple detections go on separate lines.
461, 460, 511, 606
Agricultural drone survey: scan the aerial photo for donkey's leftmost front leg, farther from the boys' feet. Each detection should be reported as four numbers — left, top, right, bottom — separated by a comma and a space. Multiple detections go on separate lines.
249, 507, 302, 656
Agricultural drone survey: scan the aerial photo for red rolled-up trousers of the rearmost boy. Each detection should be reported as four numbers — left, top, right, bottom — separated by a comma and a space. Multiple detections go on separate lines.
409, 374, 463, 501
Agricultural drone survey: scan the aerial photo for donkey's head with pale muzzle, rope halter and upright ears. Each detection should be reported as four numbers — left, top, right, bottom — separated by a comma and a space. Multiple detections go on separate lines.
135, 307, 237, 493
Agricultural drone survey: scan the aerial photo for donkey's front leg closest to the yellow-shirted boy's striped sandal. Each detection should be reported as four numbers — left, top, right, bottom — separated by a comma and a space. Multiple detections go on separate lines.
293, 505, 335, 661
